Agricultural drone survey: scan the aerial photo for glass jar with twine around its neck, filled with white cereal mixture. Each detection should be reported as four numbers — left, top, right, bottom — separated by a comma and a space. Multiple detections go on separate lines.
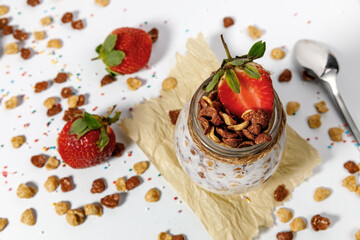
174, 78, 286, 194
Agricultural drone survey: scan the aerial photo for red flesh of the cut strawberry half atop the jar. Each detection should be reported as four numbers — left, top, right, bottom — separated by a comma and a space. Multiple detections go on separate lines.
218, 65, 274, 117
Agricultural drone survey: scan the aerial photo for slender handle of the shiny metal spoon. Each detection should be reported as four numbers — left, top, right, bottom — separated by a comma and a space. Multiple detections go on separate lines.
322, 72, 360, 150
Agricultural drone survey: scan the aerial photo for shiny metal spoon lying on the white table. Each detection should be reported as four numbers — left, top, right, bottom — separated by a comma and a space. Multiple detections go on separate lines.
295, 39, 360, 150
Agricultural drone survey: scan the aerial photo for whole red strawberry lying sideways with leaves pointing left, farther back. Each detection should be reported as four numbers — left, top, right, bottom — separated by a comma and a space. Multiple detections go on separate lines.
95, 27, 153, 75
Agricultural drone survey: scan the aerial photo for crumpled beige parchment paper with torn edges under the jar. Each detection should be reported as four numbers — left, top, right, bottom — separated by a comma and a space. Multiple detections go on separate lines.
119, 34, 321, 240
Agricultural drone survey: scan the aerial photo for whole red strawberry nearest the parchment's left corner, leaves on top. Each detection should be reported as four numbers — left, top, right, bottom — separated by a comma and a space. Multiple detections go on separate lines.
58, 106, 120, 168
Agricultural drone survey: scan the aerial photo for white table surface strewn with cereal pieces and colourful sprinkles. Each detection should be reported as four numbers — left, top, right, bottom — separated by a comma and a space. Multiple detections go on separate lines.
0, 0, 360, 240
